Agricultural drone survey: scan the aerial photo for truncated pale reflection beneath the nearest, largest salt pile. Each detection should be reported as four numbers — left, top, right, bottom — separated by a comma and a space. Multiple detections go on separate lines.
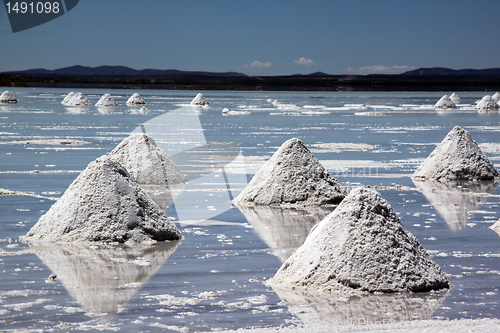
274, 289, 448, 326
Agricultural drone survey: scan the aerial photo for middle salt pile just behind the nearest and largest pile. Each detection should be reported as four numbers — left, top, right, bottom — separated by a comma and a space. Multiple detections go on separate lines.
233, 138, 347, 206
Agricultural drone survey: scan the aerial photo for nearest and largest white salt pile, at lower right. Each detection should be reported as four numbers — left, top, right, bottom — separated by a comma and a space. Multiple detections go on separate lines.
269, 187, 450, 292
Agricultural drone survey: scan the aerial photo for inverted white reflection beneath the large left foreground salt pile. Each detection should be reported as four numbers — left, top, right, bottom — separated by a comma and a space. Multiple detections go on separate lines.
32, 241, 180, 314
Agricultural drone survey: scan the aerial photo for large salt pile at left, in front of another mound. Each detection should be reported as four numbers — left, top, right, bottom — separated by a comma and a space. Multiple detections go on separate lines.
22, 156, 181, 243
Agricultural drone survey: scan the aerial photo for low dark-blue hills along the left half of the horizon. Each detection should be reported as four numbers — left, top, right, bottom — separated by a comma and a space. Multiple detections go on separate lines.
3, 65, 246, 77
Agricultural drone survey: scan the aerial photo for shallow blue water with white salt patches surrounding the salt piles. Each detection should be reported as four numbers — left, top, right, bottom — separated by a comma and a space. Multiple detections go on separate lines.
0, 89, 500, 332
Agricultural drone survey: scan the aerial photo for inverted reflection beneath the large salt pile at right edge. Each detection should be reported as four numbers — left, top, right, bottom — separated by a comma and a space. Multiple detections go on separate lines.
413, 179, 498, 230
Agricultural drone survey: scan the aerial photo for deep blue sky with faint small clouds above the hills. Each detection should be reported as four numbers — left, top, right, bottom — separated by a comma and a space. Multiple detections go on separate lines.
0, 0, 500, 75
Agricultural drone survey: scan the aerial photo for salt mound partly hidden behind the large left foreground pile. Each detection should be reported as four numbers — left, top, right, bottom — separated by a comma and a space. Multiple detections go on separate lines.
109, 133, 187, 185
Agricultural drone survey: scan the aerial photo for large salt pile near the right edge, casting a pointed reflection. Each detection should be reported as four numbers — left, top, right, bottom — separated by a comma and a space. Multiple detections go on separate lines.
412, 126, 500, 182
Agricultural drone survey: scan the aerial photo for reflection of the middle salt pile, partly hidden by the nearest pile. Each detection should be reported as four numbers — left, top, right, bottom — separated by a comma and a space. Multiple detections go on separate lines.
237, 206, 333, 262
